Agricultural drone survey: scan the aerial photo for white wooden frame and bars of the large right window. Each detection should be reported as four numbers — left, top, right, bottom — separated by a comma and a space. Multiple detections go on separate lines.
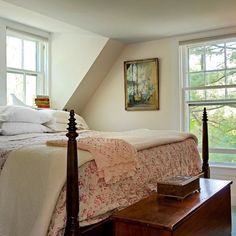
179, 37, 236, 165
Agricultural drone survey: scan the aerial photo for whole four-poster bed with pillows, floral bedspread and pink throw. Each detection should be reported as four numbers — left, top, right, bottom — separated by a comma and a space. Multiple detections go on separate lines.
0, 106, 209, 236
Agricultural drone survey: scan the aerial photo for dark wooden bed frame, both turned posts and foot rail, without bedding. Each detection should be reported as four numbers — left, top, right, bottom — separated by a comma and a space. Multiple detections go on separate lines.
64, 108, 210, 236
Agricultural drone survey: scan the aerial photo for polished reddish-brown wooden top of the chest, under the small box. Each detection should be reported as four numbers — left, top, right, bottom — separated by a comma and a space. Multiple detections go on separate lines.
114, 178, 232, 230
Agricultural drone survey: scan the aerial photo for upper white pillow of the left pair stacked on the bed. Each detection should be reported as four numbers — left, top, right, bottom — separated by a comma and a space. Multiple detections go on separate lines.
0, 106, 53, 124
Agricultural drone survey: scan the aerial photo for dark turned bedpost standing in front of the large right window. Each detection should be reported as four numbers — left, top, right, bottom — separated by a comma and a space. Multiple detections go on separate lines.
202, 107, 210, 178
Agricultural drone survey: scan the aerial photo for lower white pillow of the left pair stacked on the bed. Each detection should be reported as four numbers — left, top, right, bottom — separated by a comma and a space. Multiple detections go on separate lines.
0, 122, 51, 135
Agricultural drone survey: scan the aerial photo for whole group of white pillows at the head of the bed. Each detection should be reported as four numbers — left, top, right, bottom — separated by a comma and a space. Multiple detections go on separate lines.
0, 106, 88, 135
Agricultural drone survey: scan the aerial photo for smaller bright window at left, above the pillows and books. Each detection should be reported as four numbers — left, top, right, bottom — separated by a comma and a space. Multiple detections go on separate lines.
6, 30, 48, 106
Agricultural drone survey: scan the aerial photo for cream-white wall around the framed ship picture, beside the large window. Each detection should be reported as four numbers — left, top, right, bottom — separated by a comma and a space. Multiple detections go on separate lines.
82, 28, 236, 130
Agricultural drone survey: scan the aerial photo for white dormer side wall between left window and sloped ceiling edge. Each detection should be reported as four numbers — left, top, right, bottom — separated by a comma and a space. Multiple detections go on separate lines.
50, 31, 108, 109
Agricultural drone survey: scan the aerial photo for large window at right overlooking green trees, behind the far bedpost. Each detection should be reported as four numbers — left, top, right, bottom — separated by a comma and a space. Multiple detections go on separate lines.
181, 39, 236, 164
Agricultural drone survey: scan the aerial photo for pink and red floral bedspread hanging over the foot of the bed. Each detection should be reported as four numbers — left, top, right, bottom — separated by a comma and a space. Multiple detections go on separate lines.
0, 132, 201, 236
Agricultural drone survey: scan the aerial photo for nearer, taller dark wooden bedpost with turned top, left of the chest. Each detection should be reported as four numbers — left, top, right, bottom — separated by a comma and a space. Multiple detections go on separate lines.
65, 110, 79, 236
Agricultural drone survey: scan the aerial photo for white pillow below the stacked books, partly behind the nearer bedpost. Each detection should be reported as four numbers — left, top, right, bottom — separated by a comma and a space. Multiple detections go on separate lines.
41, 109, 89, 130
